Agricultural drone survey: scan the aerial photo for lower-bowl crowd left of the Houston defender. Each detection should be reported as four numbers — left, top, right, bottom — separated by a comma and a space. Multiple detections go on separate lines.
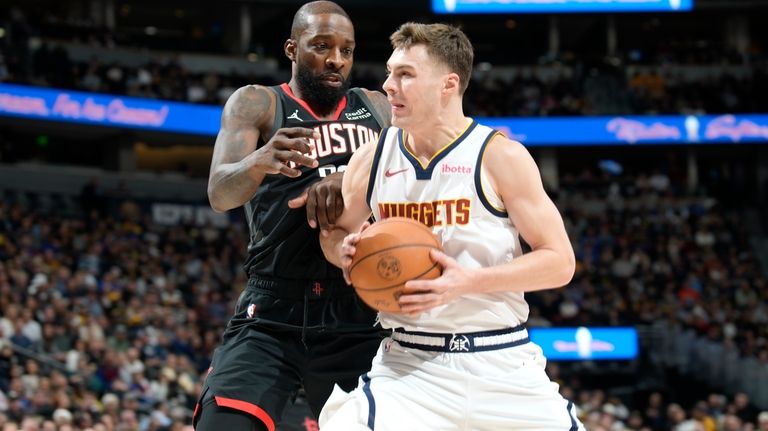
0, 193, 246, 431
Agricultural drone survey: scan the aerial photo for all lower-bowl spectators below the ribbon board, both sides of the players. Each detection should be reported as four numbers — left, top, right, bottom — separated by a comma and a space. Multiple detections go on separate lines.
0, 166, 768, 431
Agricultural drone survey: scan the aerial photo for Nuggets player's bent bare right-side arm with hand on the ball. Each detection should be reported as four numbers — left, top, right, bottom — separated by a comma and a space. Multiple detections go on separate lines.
400, 135, 575, 313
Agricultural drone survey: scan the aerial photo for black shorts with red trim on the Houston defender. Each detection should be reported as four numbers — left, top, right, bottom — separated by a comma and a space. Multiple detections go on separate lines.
193, 278, 383, 430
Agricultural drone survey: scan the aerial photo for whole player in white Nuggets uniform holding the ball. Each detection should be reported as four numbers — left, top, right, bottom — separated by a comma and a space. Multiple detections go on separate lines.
320, 23, 584, 431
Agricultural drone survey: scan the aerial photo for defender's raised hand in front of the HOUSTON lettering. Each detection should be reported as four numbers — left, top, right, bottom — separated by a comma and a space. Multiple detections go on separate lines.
252, 127, 320, 178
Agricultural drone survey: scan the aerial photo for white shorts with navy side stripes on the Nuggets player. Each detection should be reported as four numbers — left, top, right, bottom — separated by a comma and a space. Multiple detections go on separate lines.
319, 338, 584, 431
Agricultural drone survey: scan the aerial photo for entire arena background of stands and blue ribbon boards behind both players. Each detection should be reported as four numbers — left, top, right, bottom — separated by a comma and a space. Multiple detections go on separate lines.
0, 0, 768, 431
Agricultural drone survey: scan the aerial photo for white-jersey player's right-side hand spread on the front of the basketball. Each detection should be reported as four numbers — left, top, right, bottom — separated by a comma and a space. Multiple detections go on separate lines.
398, 250, 474, 315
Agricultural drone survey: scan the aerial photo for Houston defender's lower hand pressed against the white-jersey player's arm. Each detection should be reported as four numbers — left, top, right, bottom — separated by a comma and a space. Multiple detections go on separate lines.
288, 172, 344, 231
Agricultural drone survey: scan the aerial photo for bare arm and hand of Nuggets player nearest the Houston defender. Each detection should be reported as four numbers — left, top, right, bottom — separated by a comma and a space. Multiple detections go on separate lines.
320, 140, 377, 276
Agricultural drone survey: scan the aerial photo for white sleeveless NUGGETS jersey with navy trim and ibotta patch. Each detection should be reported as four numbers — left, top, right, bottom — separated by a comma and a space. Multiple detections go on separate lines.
368, 121, 528, 333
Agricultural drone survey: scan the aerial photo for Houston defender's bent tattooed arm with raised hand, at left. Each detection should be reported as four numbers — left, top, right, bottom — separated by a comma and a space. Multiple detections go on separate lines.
208, 85, 317, 212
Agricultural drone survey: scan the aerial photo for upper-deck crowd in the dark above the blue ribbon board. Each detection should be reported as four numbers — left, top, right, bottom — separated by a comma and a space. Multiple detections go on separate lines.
0, 39, 768, 116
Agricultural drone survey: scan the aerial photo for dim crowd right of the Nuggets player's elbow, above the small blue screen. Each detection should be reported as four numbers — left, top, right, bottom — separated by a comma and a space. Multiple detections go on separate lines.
544, 171, 768, 364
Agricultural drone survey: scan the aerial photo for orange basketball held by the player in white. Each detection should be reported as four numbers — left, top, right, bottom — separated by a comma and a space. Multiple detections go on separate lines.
349, 217, 442, 313
